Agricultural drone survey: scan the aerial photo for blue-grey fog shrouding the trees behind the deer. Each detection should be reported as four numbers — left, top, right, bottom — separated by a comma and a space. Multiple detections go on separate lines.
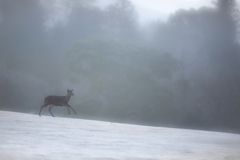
0, 0, 240, 133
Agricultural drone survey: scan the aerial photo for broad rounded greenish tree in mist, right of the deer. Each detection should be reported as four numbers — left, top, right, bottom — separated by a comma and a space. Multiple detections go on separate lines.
67, 38, 175, 124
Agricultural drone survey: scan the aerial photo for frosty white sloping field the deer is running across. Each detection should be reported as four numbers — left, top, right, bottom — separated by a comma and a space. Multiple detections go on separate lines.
0, 111, 240, 160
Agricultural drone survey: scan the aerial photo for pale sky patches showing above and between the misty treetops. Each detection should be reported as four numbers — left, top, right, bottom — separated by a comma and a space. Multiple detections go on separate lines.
44, 0, 240, 27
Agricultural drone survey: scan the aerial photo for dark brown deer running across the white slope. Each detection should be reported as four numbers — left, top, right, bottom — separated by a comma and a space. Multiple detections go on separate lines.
39, 89, 76, 117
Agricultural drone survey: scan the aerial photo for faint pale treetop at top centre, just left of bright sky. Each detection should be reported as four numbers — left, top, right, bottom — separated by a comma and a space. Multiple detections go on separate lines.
104, 0, 140, 41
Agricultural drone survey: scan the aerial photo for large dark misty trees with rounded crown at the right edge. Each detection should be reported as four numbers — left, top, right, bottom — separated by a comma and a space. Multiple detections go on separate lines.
150, 0, 240, 128
